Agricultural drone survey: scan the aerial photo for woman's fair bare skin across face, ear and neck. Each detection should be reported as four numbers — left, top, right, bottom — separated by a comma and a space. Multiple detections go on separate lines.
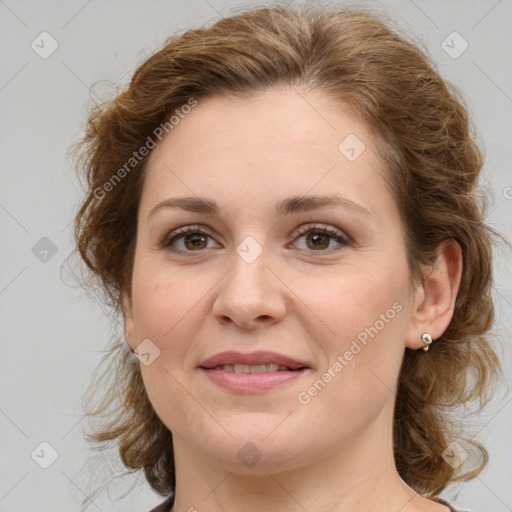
124, 89, 462, 512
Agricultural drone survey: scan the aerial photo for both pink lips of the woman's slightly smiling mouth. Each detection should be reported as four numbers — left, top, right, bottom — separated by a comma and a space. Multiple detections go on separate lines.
199, 351, 309, 394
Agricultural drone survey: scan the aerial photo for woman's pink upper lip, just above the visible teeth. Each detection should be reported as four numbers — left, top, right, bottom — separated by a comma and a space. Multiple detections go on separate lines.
199, 350, 309, 373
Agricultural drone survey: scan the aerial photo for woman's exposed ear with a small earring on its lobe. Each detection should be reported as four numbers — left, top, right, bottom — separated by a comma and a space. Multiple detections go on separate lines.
405, 240, 463, 350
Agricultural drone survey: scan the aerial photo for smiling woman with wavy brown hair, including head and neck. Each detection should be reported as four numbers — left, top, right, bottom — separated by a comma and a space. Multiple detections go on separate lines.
76, 7, 499, 512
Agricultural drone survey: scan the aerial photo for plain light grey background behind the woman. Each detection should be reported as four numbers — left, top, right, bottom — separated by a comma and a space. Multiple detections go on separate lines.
0, 0, 512, 512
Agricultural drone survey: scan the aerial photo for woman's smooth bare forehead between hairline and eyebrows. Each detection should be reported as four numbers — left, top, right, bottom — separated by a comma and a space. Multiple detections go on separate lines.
141, 89, 389, 220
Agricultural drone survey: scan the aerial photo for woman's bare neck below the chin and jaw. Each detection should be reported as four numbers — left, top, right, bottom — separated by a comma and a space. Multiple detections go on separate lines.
173, 404, 434, 512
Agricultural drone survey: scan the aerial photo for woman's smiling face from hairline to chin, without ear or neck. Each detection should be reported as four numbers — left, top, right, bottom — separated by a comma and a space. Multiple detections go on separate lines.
125, 89, 421, 472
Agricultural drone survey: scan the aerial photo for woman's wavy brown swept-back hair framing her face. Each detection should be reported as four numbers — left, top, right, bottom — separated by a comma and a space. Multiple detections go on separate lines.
70, 2, 501, 506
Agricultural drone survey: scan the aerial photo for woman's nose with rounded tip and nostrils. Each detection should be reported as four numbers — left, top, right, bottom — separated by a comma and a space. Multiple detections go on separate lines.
212, 246, 287, 329
